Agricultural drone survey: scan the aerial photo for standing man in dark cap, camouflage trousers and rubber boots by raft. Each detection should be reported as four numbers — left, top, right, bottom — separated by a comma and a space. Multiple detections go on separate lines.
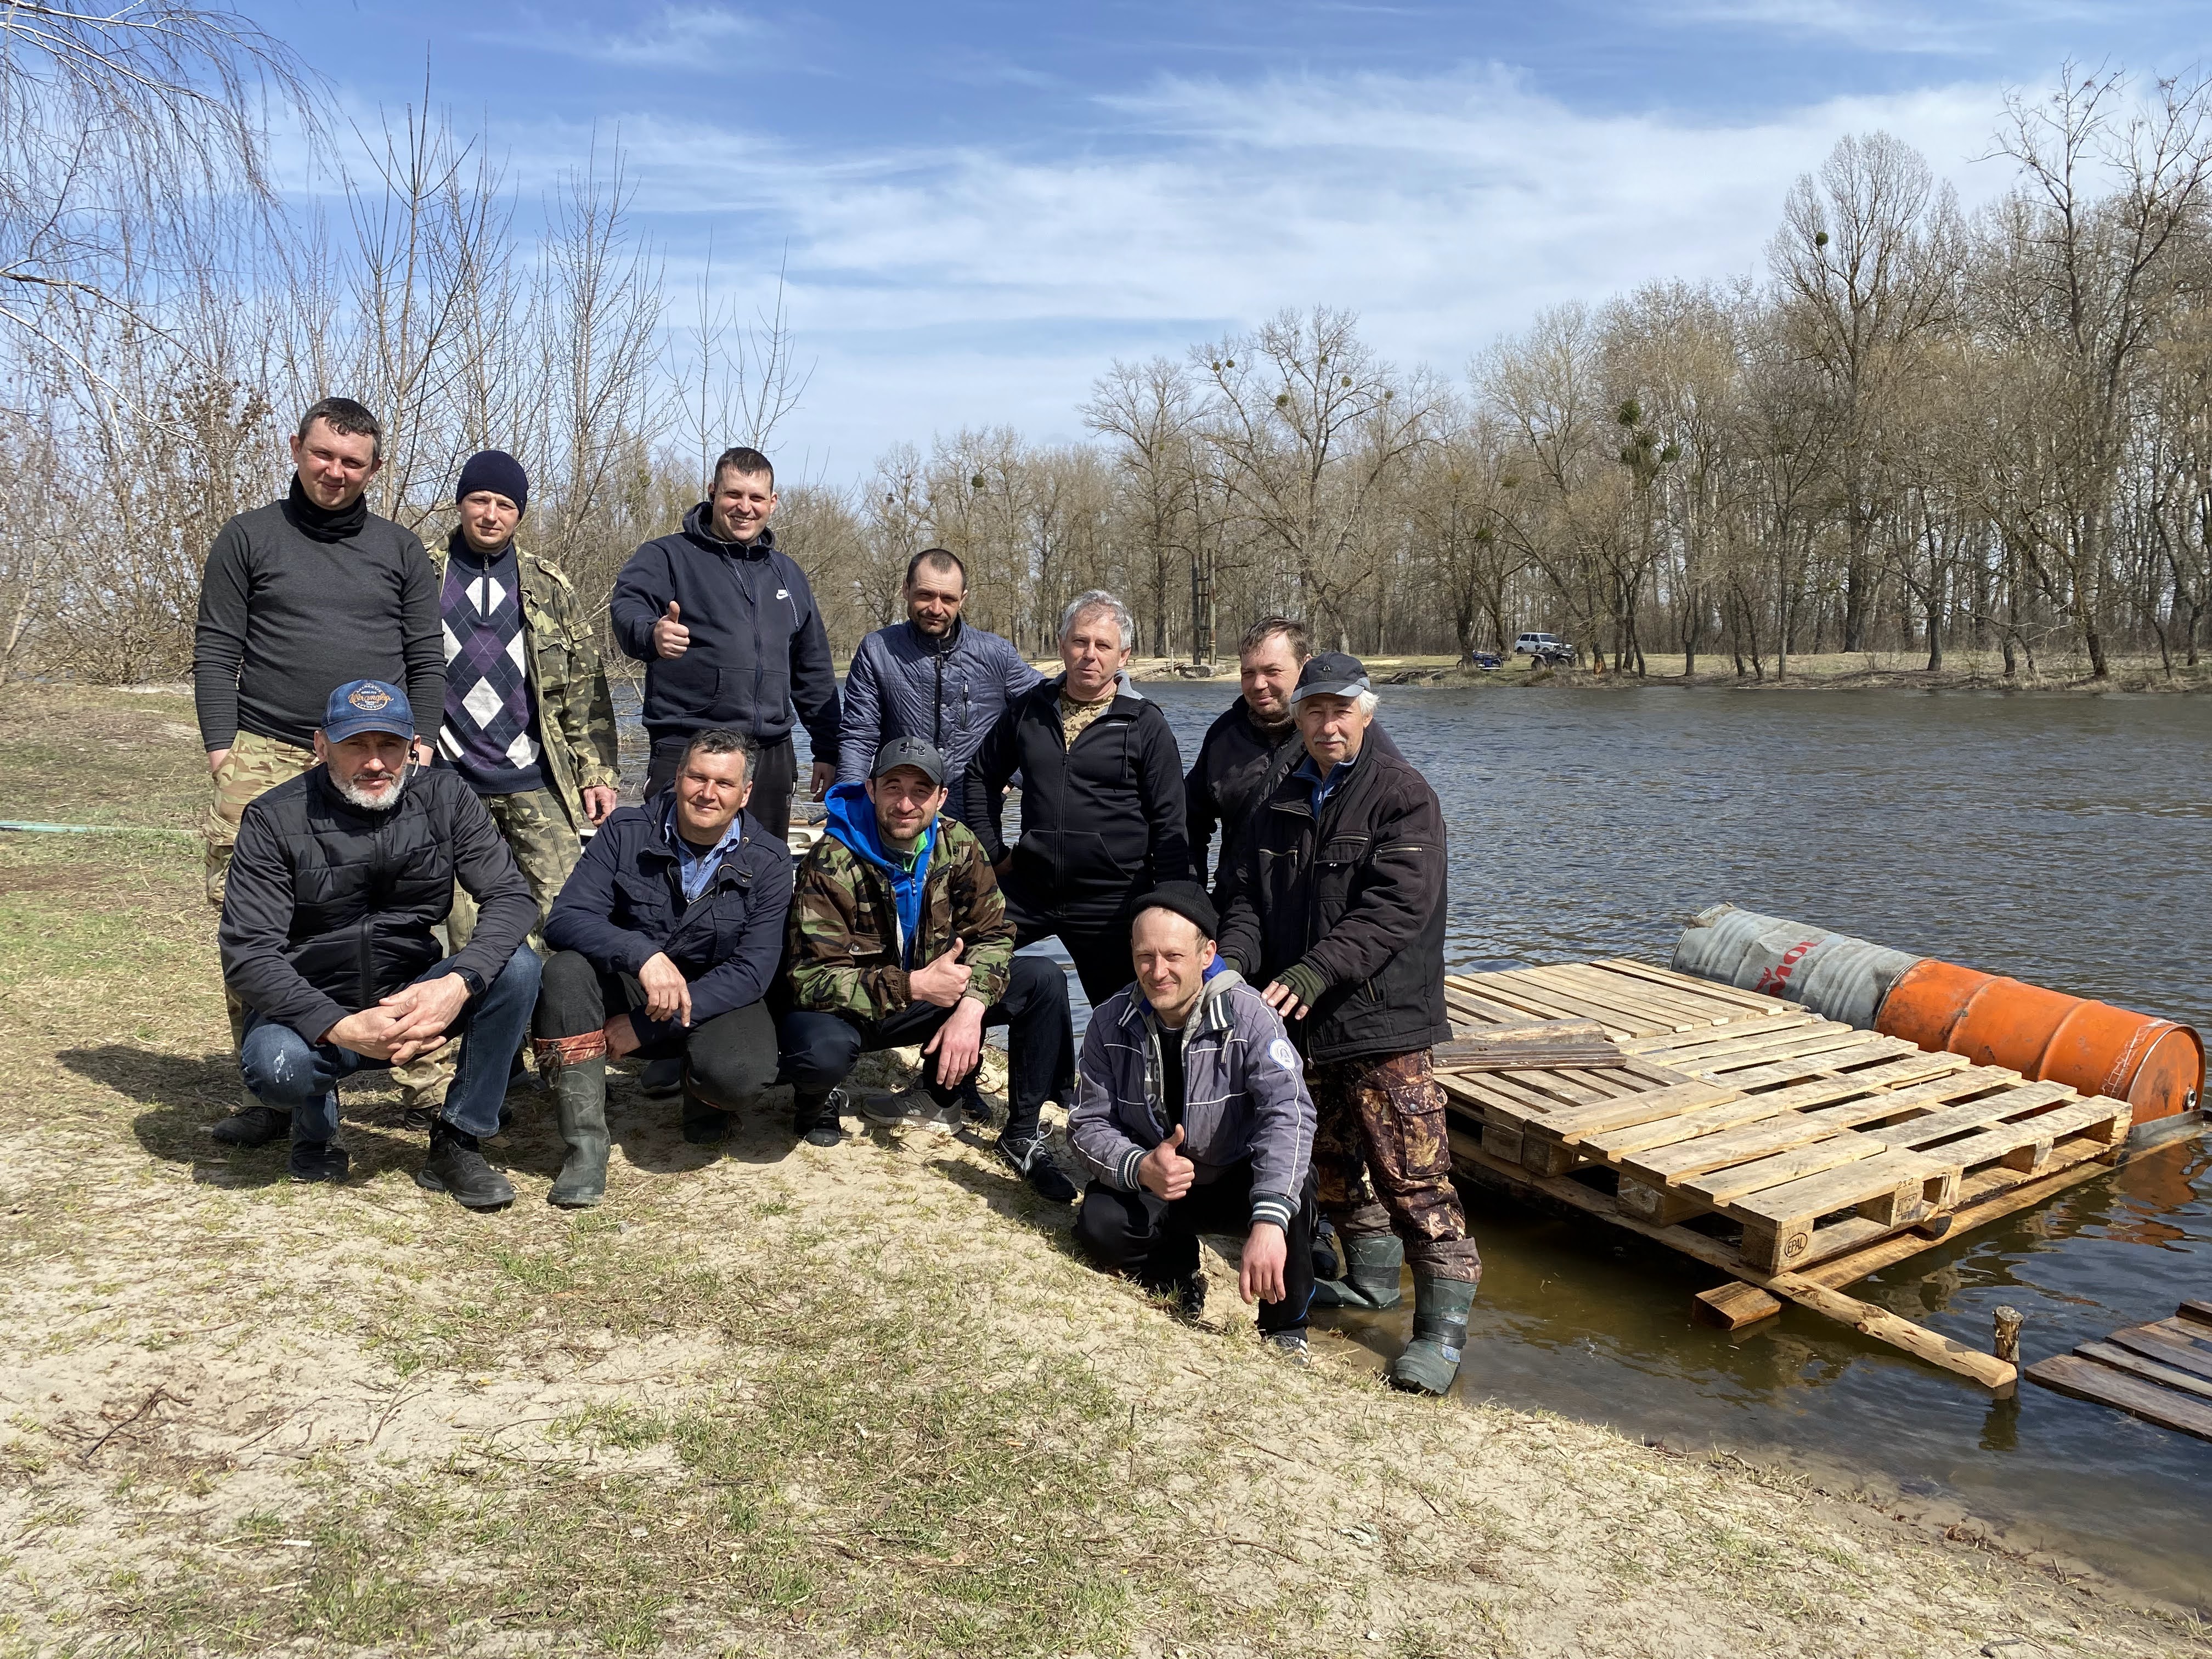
1221, 652, 1482, 1393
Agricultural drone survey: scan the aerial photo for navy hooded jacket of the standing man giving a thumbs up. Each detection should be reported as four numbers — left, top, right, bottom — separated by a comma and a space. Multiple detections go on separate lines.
608, 513, 838, 765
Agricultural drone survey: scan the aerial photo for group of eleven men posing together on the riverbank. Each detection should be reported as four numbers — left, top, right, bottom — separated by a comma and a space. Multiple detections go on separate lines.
195, 398, 1480, 1393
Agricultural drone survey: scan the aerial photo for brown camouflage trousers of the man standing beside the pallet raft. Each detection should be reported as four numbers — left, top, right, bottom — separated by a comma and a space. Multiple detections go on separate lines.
1305, 1048, 1482, 1283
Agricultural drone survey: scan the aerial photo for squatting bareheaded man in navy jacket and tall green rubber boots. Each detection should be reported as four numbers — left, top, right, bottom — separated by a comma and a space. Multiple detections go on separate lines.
533, 728, 792, 1207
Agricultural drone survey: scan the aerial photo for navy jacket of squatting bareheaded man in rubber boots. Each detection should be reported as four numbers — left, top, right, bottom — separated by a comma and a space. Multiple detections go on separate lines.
544, 796, 792, 1044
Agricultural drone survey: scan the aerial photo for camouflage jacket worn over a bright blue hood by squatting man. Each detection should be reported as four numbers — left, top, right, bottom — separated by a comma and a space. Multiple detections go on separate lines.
783, 816, 1013, 1020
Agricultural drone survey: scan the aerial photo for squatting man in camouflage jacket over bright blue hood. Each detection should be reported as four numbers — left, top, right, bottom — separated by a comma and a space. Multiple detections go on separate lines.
781, 737, 1075, 1203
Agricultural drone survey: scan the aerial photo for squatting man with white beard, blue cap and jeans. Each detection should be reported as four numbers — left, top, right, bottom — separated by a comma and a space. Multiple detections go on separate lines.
219, 679, 538, 1210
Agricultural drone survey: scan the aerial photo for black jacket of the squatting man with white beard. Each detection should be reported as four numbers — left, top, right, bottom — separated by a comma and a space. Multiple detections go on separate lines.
219, 765, 538, 1042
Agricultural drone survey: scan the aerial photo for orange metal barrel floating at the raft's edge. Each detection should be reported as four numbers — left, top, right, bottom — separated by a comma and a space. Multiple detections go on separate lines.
1874, 958, 2205, 1124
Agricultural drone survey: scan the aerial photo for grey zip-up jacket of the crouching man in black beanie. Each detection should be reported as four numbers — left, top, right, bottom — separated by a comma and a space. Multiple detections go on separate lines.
1068, 971, 1314, 1232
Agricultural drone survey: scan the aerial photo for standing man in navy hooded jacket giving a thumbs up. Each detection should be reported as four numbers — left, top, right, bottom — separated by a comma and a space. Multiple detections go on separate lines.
608, 449, 838, 840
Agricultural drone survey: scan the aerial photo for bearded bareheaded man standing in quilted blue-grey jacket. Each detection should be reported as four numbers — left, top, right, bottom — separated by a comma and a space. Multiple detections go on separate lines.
838, 546, 1040, 819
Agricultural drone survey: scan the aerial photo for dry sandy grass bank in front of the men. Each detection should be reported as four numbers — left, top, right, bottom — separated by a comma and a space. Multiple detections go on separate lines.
0, 695, 2203, 1659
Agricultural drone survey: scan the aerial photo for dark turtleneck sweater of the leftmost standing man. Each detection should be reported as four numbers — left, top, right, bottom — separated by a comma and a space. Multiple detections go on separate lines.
193, 478, 444, 750
